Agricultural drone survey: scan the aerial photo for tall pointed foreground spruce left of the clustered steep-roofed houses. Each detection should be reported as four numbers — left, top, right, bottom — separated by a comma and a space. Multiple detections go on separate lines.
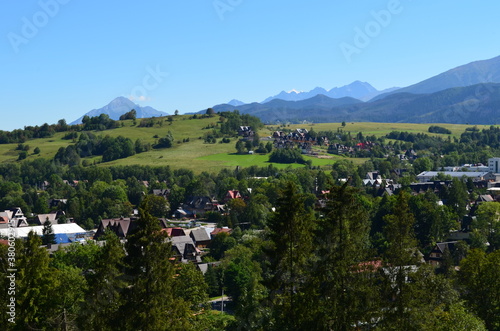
121, 200, 189, 331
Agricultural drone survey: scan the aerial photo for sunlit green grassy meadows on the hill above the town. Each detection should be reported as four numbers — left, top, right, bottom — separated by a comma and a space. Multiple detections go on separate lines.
0, 115, 489, 173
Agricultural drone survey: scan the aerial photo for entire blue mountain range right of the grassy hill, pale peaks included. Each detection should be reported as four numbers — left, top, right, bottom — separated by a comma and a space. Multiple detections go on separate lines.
209, 56, 500, 124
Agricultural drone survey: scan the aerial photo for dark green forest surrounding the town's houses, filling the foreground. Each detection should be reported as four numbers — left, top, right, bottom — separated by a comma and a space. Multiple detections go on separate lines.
0, 154, 500, 330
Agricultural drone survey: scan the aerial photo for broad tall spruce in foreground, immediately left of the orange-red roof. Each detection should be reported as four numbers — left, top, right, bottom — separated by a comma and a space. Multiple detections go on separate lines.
310, 182, 376, 330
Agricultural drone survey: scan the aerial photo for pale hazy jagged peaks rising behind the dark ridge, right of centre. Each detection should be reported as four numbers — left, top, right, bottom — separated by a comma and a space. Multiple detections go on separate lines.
261, 80, 398, 103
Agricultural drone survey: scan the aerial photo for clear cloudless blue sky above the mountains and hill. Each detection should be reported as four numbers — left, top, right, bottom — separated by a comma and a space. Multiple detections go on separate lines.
0, 0, 500, 130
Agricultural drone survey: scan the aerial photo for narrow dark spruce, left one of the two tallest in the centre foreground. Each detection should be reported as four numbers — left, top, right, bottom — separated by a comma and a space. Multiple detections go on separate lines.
267, 182, 315, 330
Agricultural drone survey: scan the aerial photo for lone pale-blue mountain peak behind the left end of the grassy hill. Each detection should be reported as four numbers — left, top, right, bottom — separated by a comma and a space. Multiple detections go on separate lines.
70, 97, 168, 124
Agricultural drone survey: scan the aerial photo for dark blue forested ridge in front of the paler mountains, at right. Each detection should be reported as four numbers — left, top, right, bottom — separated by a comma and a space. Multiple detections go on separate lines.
204, 83, 500, 124
